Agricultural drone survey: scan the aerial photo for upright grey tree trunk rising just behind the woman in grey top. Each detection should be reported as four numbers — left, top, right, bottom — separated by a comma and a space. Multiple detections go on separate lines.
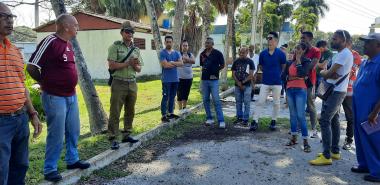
173, 0, 186, 51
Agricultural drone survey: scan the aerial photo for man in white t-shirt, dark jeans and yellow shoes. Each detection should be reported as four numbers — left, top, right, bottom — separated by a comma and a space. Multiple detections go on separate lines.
309, 30, 354, 166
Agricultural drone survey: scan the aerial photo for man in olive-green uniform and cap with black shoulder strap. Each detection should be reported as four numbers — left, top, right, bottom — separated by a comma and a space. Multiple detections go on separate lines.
108, 21, 143, 150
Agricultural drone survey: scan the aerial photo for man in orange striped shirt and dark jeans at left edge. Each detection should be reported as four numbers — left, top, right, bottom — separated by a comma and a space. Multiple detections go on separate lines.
0, 2, 42, 185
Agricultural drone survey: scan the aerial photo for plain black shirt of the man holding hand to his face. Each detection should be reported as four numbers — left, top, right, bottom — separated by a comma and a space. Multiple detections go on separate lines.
200, 49, 224, 80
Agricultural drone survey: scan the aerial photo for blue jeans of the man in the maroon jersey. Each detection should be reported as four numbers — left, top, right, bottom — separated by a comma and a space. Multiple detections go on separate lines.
42, 92, 80, 175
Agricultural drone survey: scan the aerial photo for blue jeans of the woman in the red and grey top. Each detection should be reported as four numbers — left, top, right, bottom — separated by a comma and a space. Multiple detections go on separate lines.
286, 88, 308, 139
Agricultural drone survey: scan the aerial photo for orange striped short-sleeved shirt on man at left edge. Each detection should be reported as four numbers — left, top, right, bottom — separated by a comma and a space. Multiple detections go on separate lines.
0, 38, 26, 113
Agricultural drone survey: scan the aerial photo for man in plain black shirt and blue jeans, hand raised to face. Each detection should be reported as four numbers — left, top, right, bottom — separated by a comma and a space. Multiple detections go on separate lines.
200, 37, 226, 129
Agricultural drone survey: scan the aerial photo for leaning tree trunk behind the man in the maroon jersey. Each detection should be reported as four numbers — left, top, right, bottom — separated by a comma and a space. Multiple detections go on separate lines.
50, 0, 108, 134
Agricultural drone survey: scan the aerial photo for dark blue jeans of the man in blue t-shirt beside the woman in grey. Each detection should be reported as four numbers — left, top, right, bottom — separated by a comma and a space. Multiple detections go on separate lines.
161, 82, 178, 116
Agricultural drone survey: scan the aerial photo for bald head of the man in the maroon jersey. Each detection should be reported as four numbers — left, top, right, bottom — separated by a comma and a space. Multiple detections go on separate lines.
55, 14, 79, 40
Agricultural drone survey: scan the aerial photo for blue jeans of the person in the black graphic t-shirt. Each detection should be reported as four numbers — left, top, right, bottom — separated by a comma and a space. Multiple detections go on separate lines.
235, 84, 252, 121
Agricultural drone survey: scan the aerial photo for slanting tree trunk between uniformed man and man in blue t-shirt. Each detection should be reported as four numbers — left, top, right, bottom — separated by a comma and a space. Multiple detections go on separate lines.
144, 0, 164, 58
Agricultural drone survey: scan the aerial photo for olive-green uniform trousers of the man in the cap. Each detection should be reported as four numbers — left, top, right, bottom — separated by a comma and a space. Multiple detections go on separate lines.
108, 79, 137, 140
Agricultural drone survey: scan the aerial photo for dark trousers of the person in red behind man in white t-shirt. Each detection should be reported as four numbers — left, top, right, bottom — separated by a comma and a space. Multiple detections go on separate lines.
342, 96, 354, 143
